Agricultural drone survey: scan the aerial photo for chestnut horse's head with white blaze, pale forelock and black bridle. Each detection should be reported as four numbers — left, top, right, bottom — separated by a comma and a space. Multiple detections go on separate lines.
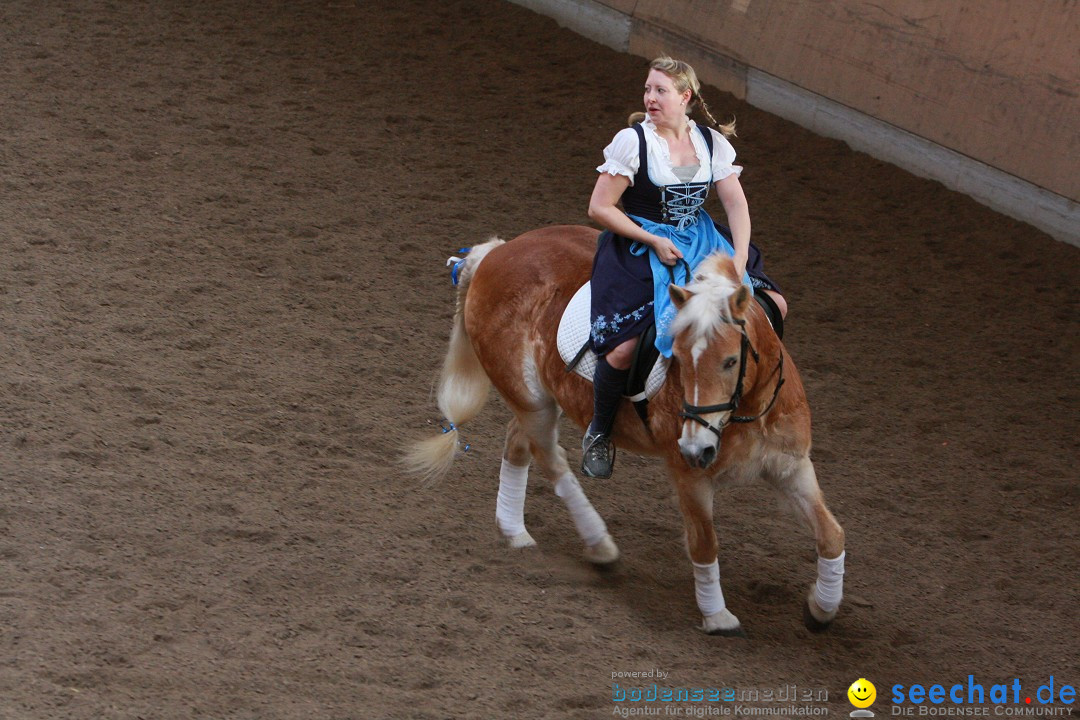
669, 250, 757, 468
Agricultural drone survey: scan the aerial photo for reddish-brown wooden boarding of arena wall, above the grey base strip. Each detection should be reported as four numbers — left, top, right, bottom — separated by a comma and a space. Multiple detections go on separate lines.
631, 0, 1080, 200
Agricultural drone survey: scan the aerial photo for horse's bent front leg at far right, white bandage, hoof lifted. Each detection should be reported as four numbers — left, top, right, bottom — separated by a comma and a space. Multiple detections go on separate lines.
771, 458, 846, 633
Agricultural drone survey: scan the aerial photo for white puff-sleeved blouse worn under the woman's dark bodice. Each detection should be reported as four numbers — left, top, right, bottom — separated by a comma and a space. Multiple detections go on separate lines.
596, 118, 742, 187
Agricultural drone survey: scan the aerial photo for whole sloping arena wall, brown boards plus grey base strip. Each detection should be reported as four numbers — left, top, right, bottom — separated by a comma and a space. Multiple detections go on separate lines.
512, 0, 1080, 245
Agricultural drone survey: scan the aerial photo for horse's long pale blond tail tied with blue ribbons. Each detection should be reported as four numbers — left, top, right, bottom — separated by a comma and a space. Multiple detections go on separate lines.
403, 237, 504, 483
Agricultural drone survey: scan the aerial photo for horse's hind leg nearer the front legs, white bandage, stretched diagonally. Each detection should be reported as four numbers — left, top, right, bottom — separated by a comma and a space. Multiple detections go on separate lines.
516, 403, 619, 566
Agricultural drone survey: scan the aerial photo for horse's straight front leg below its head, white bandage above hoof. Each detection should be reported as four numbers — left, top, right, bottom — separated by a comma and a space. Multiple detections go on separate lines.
672, 467, 744, 637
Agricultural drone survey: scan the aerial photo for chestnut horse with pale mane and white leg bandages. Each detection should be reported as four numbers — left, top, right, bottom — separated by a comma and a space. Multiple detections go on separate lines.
403, 226, 845, 636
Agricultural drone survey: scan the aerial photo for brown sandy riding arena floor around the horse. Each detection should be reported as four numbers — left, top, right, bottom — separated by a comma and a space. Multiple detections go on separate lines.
0, 0, 1080, 720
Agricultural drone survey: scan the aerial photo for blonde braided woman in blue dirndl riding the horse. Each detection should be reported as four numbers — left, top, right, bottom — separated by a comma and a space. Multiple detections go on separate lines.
581, 56, 787, 478
